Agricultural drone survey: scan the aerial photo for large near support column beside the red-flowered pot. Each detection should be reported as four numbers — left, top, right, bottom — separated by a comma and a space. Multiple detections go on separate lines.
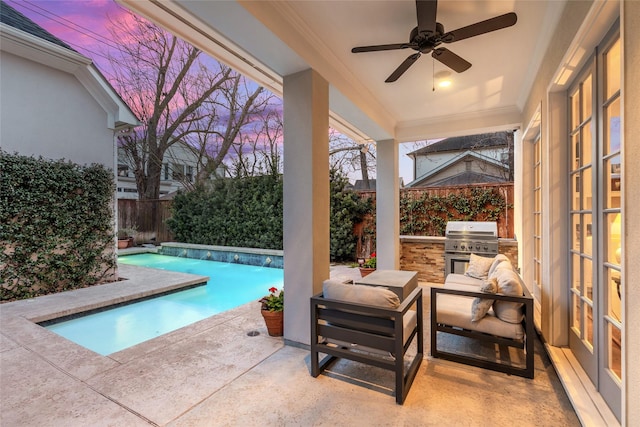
283, 70, 329, 344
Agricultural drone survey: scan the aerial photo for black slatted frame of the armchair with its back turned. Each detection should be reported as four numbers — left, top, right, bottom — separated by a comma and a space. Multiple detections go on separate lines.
311, 288, 424, 405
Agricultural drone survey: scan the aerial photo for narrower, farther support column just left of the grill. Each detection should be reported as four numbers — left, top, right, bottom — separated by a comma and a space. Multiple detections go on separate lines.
376, 139, 400, 270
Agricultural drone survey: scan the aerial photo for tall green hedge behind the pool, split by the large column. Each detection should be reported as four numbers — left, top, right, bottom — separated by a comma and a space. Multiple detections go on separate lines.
167, 172, 371, 261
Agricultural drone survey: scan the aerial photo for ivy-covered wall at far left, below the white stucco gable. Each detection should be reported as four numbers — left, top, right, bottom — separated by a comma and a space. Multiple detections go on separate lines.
0, 151, 116, 301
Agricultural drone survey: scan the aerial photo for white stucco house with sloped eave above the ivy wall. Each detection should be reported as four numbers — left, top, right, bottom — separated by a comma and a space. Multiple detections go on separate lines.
0, 2, 138, 170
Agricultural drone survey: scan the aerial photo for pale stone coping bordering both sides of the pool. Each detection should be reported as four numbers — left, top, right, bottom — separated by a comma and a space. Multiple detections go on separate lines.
0, 264, 252, 372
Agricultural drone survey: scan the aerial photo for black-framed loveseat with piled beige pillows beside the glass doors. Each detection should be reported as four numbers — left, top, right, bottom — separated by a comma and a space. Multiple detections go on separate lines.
431, 255, 536, 378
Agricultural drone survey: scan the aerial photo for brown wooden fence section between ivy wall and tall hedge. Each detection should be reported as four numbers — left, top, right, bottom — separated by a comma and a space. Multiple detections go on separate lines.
118, 199, 173, 244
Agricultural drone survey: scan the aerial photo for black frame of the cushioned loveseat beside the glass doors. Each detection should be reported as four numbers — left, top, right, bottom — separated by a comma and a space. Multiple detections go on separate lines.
431, 288, 536, 378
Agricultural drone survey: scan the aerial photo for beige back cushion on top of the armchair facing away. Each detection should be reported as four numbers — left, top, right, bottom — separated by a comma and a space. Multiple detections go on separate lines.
322, 280, 400, 308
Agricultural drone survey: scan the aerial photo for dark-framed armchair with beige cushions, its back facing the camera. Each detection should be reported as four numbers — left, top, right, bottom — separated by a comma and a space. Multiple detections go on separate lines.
311, 280, 424, 404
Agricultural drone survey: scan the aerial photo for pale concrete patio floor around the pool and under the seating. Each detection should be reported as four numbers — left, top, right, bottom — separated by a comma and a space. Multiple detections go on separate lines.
0, 264, 579, 427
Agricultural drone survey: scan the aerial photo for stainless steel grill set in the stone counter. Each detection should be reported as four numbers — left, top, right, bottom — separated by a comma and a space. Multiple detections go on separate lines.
444, 221, 498, 274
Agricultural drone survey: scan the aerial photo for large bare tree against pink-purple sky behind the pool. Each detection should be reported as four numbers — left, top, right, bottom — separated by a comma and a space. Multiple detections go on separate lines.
108, 14, 269, 199
